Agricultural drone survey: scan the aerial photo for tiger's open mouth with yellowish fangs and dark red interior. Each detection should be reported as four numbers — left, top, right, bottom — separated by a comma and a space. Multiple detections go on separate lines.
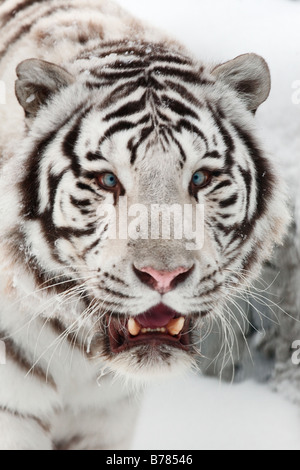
107, 304, 191, 354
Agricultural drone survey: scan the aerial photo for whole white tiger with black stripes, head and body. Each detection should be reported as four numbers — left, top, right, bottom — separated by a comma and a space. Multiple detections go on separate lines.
0, 0, 289, 450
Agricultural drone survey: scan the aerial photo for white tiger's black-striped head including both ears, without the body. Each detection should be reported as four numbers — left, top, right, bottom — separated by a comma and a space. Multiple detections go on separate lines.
16, 43, 287, 377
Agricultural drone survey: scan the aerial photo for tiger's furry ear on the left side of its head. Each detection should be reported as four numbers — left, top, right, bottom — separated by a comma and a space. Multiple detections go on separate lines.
15, 59, 75, 119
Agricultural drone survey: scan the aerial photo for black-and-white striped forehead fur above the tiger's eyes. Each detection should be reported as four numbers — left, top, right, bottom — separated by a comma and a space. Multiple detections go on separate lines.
72, 44, 209, 166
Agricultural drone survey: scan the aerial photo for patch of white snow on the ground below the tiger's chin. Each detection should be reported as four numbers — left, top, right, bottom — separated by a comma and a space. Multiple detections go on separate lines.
133, 376, 300, 450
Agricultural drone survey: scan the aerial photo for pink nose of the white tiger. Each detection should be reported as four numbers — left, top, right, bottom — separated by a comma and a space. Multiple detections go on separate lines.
134, 266, 194, 294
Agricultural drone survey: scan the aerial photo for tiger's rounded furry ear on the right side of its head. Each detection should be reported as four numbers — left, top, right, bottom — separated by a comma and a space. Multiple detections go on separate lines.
212, 54, 271, 112
